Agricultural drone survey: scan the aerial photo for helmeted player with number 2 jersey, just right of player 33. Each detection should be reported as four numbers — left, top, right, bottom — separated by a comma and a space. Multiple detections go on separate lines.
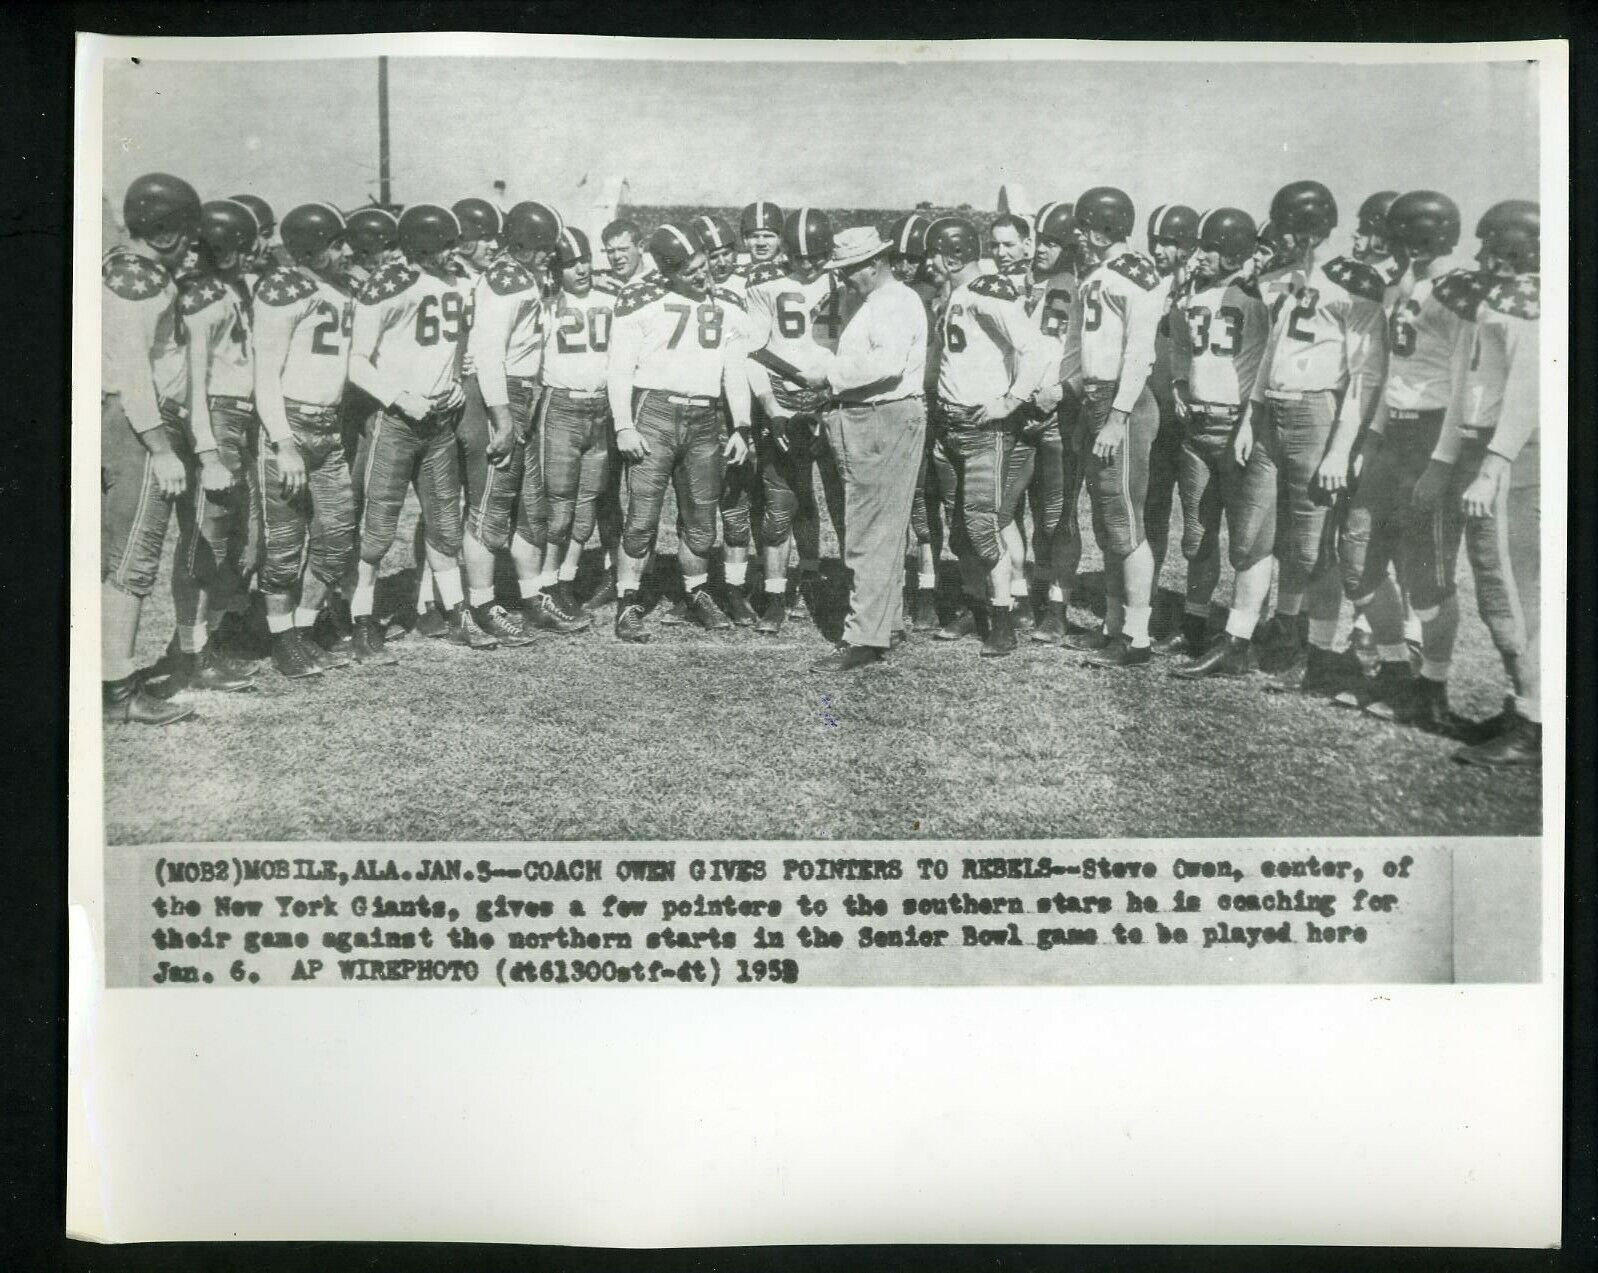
1248, 180, 1400, 696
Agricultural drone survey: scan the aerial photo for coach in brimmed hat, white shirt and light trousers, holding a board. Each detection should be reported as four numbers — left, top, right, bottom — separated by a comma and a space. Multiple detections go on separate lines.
805, 225, 927, 672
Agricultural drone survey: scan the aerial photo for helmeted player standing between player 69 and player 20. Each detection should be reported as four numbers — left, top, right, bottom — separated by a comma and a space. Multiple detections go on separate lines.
460, 201, 591, 645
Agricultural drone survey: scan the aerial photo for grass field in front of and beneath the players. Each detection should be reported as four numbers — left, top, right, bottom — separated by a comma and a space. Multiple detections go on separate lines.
105, 482, 1540, 843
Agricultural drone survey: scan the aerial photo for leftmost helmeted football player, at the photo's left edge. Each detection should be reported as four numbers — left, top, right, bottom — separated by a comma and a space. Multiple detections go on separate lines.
101, 173, 200, 725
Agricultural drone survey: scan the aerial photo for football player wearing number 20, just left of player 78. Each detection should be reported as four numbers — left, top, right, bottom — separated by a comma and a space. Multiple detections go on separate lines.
539, 225, 620, 620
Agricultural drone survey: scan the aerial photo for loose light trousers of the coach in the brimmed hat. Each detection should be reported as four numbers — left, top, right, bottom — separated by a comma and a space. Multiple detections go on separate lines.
826, 398, 927, 650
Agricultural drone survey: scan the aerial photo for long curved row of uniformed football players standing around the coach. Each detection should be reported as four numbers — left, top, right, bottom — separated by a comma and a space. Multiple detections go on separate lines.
102, 174, 1540, 763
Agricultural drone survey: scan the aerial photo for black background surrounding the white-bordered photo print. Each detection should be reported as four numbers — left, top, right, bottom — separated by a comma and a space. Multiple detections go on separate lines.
0, 0, 1598, 1273
